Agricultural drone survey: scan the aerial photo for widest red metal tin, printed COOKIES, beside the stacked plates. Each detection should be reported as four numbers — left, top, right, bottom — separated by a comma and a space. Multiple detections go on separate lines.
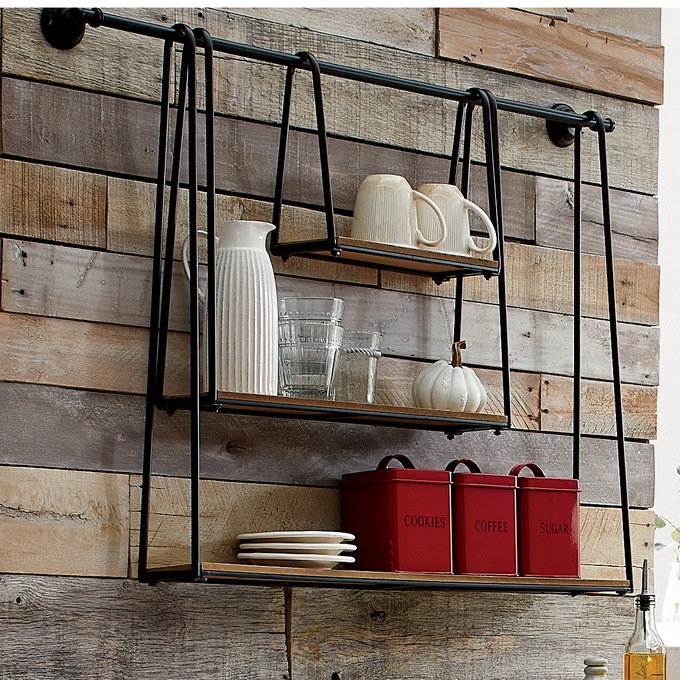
341, 455, 451, 573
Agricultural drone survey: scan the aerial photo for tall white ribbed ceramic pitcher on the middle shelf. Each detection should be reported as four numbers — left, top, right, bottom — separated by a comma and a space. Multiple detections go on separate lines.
182, 220, 278, 395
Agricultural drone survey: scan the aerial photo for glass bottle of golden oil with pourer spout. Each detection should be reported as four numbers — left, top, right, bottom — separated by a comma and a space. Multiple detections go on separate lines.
623, 560, 666, 680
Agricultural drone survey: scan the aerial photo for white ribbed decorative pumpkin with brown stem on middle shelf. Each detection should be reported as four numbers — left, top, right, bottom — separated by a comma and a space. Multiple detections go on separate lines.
412, 341, 486, 413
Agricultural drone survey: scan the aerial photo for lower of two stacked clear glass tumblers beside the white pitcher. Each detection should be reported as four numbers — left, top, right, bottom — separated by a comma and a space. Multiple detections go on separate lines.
279, 319, 343, 400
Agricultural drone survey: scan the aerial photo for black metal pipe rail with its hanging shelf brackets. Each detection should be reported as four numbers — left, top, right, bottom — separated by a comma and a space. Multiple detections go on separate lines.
34, 8, 633, 593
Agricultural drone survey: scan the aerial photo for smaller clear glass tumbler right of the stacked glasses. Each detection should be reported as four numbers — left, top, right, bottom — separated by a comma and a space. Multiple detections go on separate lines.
335, 329, 382, 404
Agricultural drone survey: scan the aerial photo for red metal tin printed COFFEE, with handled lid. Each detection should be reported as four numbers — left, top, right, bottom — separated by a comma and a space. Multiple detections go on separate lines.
446, 460, 517, 576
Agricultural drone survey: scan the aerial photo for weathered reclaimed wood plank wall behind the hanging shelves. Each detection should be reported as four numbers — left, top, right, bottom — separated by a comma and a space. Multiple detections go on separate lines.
0, 8, 663, 680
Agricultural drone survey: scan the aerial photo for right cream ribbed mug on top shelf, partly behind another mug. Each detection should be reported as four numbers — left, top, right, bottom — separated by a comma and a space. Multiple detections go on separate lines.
417, 184, 496, 257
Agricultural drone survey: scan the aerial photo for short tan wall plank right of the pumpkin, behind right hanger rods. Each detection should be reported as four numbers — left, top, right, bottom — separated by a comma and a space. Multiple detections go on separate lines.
541, 376, 656, 439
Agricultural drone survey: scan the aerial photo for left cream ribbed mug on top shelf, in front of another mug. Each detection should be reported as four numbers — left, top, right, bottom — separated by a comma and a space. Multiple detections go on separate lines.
350, 175, 446, 248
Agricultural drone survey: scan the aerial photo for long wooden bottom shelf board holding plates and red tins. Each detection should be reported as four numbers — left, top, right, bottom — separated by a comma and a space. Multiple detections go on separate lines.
149, 562, 629, 593
